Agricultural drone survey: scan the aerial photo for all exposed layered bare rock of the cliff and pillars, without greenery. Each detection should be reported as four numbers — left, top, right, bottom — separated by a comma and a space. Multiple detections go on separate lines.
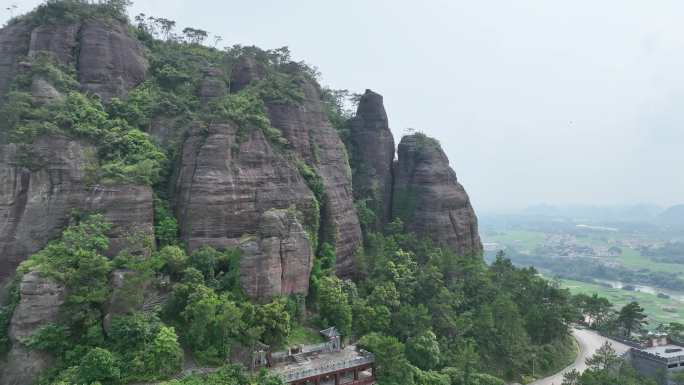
0, 9, 481, 385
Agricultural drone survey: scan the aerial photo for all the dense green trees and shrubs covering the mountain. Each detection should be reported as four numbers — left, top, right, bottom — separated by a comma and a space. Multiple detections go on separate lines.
0, 0, 672, 385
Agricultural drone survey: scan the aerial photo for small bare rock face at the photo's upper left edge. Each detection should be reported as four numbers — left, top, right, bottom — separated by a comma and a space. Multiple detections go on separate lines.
0, 23, 31, 100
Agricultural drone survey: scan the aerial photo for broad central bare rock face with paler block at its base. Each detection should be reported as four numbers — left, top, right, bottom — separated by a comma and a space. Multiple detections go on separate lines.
174, 123, 316, 298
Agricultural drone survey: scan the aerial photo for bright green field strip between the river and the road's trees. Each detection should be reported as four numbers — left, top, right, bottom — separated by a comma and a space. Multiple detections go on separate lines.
560, 279, 684, 328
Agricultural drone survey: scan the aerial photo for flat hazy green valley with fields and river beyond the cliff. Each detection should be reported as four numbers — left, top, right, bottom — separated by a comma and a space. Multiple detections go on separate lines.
485, 229, 684, 329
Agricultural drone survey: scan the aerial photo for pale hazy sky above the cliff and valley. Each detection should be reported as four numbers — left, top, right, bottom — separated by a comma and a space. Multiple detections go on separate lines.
0, 0, 684, 210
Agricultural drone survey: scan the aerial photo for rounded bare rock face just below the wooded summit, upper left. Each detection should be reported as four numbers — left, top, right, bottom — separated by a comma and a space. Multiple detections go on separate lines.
78, 21, 147, 101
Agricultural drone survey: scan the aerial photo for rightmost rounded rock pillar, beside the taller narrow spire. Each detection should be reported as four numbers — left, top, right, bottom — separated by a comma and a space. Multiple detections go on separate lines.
392, 134, 482, 254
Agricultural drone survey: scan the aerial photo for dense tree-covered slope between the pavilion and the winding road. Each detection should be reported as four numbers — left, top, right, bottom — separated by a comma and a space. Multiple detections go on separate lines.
334, 224, 577, 384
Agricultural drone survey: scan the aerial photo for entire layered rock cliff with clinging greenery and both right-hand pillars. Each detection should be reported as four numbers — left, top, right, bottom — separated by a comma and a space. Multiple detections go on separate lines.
0, 2, 482, 385
